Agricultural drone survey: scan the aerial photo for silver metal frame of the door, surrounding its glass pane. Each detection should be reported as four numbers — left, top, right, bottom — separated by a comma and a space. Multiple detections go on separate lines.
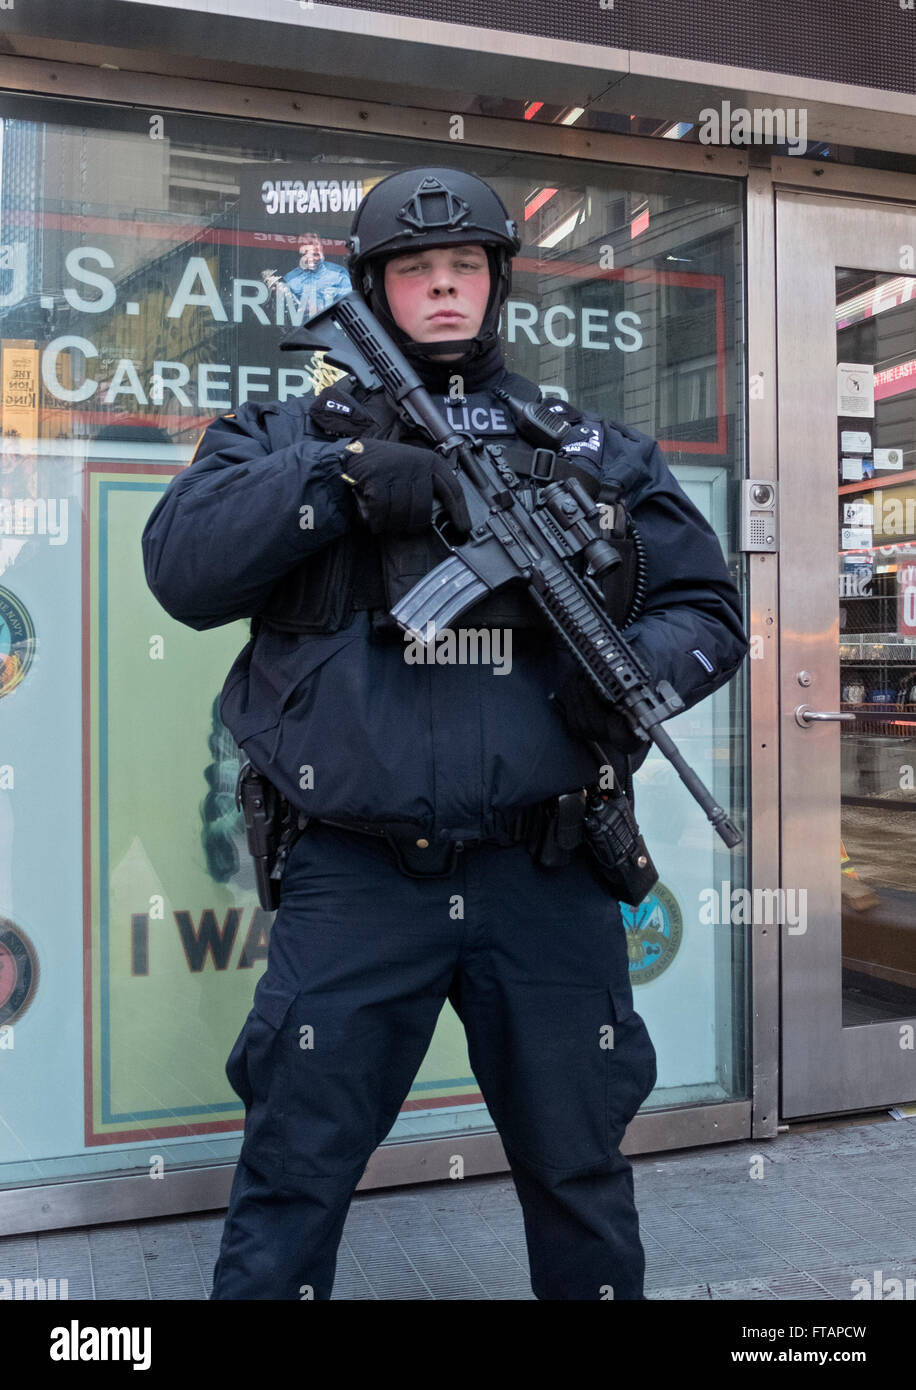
774, 182, 916, 1118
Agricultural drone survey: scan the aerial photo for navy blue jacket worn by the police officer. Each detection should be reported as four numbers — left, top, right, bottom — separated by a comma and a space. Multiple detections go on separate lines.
143, 368, 748, 840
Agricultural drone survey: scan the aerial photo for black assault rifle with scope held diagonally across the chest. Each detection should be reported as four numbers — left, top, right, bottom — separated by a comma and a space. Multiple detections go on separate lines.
279, 291, 741, 849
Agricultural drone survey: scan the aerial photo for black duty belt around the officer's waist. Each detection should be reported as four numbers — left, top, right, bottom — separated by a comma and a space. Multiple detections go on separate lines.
299, 792, 585, 878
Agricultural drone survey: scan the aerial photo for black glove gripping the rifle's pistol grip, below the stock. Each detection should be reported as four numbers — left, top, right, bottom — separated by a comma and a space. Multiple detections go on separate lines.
343, 439, 471, 535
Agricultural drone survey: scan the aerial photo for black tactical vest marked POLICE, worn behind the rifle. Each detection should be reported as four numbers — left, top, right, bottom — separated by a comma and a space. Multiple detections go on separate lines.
256, 373, 644, 639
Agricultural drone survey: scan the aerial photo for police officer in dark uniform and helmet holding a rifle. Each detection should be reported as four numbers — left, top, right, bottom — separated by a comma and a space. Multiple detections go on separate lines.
143, 168, 748, 1300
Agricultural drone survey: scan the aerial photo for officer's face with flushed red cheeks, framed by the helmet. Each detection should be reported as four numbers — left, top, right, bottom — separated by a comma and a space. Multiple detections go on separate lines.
385, 246, 489, 361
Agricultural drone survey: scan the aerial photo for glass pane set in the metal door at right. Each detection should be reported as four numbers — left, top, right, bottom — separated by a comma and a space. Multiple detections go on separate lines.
837, 267, 916, 1027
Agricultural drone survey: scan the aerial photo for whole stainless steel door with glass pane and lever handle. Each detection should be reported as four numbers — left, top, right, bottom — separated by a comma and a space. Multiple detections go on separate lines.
777, 190, 916, 1118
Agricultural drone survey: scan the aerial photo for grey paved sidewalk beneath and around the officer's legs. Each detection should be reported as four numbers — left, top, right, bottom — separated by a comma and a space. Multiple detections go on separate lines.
0, 1112, 916, 1301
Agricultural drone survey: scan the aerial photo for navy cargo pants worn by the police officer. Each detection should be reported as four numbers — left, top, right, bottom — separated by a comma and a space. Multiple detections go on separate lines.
211, 821, 656, 1300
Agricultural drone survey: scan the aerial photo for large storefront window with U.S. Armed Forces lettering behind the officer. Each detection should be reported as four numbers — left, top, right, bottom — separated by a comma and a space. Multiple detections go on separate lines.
0, 96, 748, 1186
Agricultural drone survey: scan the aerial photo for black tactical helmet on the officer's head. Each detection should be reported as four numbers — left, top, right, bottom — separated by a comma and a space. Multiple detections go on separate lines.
347, 168, 521, 360
